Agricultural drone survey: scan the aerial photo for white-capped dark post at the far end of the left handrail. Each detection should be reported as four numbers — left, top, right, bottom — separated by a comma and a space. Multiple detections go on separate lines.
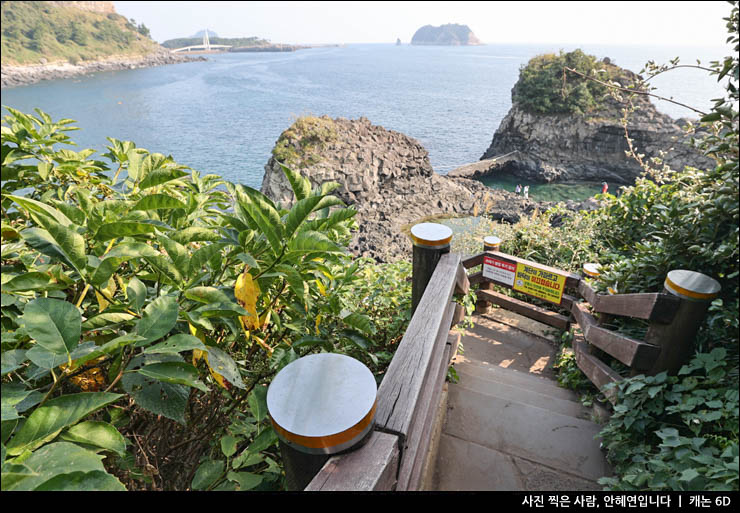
411, 223, 452, 316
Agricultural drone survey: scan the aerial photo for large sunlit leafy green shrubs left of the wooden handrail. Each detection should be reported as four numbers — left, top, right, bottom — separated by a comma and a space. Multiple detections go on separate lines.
0, 108, 410, 490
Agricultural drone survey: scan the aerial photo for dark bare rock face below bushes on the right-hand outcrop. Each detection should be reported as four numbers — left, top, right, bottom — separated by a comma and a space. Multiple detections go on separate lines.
472, 66, 714, 184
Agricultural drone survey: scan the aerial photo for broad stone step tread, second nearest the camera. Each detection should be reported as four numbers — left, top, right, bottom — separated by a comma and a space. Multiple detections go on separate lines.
443, 385, 609, 481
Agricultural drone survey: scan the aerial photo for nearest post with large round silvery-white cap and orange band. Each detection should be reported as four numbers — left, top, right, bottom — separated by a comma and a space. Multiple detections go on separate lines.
267, 353, 378, 491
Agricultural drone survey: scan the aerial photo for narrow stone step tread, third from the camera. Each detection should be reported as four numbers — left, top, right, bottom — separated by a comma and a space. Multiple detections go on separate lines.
454, 357, 578, 402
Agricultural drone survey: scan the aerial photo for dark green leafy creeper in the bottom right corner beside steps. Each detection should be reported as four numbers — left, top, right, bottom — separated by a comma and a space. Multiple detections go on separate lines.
599, 348, 738, 491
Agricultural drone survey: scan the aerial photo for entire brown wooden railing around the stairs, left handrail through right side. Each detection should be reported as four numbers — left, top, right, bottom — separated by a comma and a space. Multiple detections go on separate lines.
305, 242, 718, 491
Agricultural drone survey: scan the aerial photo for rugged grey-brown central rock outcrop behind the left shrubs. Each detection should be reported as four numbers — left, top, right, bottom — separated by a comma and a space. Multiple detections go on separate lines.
262, 117, 539, 261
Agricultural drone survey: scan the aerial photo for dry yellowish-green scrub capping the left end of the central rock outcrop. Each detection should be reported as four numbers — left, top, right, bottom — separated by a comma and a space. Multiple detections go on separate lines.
272, 116, 337, 169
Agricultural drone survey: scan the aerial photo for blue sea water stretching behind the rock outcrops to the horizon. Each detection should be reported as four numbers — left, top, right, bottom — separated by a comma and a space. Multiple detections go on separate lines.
2, 44, 727, 199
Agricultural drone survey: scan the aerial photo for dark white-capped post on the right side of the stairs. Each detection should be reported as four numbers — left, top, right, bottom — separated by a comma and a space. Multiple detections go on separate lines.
645, 269, 721, 375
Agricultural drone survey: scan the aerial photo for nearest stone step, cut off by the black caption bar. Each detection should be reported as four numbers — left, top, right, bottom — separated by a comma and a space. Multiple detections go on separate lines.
432, 433, 601, 492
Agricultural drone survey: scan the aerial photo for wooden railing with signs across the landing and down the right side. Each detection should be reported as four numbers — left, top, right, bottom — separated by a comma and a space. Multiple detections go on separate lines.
462, 251, 713, 402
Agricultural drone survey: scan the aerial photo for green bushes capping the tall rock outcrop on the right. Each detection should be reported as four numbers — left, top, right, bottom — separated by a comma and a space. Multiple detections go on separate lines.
511, 50, 620, 115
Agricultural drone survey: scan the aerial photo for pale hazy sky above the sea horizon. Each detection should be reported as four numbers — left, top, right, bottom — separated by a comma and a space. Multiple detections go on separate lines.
114, 0, 730, 47
